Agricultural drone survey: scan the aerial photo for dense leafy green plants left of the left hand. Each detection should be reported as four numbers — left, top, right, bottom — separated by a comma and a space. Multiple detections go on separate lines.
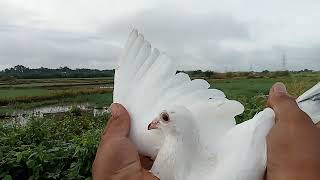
0, 113, 108, 180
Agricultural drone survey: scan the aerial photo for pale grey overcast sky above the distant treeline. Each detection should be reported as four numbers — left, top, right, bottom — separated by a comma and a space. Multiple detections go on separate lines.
0, 0, 320, 71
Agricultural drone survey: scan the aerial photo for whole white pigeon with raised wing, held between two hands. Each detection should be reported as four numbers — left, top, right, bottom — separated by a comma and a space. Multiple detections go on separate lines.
114, 30, 320, 180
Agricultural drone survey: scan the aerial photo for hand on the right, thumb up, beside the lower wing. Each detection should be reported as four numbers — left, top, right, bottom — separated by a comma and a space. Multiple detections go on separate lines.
266, 83, 320, 180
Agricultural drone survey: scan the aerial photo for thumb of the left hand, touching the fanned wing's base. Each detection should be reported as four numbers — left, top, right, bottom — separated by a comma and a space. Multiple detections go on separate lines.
103, 103, 130, 137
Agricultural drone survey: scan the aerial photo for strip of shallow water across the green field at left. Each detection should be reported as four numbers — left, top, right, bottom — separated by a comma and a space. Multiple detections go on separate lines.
3, 103, 108, 123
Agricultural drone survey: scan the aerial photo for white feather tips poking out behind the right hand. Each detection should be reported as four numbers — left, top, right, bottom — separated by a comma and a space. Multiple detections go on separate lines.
297, 83, 320, 123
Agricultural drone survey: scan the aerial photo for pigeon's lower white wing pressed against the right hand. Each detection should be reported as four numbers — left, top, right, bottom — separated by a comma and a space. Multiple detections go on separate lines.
203, 108, 274, 180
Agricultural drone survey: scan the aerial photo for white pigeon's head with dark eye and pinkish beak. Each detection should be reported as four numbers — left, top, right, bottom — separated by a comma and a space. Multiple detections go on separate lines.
148, 106, 192, 135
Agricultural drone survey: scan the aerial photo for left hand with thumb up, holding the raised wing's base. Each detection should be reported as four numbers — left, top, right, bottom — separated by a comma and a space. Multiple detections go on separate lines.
92, 103, 157, 180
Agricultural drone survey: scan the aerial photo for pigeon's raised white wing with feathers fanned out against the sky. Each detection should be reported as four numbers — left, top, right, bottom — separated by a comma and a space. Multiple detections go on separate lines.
114, 30, 241, 157
